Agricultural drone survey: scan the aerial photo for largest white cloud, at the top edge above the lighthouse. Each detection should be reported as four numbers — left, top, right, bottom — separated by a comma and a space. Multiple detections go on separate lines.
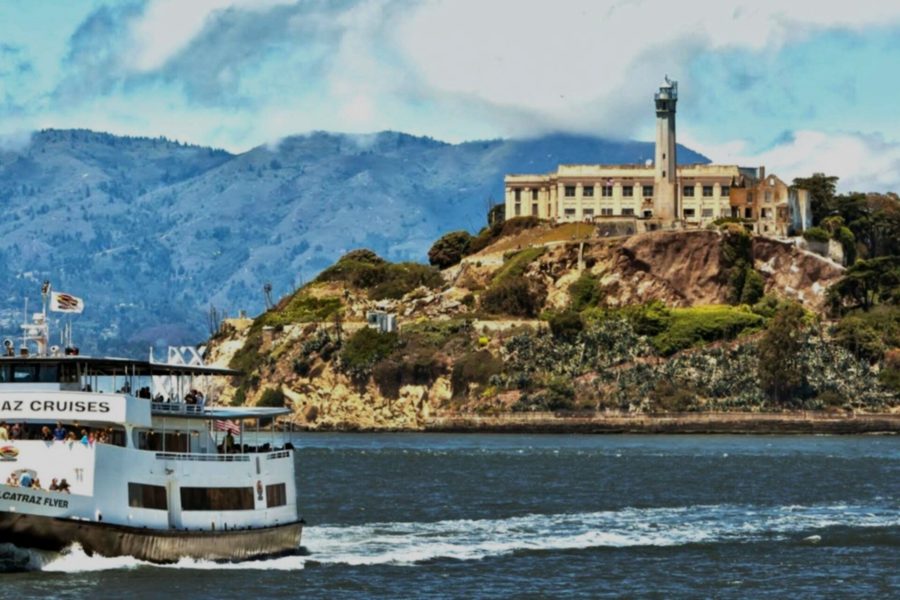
397, 0, 900, 130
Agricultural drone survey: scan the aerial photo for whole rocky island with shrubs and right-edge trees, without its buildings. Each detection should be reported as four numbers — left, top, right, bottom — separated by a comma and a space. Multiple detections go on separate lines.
210, 210, 900, 432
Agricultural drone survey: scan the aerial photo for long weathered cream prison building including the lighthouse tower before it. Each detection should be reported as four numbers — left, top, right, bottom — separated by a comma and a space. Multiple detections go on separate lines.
505, 78, 812, 236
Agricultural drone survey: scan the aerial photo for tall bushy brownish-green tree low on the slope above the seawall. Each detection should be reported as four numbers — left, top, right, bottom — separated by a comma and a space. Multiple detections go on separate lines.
757, 303, 809, 404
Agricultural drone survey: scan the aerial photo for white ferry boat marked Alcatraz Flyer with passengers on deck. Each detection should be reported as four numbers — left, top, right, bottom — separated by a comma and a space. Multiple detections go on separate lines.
0, 284, 303, 563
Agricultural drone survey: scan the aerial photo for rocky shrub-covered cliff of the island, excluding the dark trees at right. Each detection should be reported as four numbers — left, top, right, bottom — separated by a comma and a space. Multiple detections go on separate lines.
210, 225, 896, 430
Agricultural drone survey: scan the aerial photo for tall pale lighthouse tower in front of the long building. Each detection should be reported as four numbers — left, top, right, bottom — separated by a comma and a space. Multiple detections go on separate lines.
653, 76, 678, 221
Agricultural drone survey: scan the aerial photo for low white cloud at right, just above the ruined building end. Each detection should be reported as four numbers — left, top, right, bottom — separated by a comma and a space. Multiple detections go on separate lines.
679, 131, 900, 192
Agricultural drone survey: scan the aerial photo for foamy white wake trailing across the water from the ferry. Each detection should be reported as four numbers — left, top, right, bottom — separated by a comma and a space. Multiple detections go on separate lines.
8, 505, 900, 572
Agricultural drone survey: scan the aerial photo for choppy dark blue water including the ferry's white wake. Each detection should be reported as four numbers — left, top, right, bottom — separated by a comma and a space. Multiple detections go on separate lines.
0, 435, 900, 598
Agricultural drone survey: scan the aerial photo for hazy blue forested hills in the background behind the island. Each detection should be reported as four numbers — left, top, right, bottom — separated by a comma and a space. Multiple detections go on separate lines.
0, 130, 708, 352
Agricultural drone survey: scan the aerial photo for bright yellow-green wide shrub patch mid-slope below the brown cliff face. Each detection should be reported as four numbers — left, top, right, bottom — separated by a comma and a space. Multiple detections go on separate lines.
652, 305, 765, 356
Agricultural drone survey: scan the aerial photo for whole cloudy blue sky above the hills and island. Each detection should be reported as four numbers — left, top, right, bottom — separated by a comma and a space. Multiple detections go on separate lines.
0, 0, 900, 192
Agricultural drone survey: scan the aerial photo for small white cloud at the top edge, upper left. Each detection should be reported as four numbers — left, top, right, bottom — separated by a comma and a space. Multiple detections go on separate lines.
130, 0, 296, 71
